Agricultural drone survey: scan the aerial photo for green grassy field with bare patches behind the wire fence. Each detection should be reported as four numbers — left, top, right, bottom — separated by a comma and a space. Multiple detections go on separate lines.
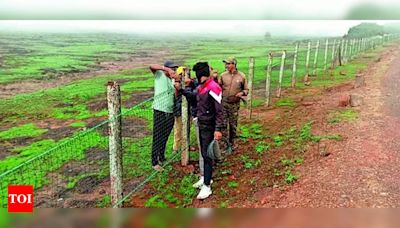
0, 33, 388, 207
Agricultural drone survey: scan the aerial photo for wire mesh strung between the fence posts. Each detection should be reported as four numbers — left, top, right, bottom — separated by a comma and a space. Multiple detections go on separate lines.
0, 34, 396, 207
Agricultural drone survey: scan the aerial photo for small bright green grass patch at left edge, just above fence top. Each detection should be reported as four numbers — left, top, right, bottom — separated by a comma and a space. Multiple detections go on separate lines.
0, 123, 48, 139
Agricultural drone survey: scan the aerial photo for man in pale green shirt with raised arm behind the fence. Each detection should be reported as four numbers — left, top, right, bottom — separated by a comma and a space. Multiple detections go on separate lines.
150, 60, 178, 171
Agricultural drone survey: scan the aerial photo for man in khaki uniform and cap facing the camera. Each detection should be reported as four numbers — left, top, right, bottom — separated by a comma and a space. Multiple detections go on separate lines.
218, 57, 249, 149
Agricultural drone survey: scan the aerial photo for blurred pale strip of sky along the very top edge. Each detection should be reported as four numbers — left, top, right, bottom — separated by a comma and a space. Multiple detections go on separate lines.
0, 0, 400, 19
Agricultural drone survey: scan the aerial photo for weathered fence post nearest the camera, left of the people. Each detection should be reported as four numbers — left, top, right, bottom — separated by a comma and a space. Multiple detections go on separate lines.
107, 81, 122, 208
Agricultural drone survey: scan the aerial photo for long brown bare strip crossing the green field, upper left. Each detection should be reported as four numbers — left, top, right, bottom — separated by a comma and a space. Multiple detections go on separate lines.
0, 50, 169, 99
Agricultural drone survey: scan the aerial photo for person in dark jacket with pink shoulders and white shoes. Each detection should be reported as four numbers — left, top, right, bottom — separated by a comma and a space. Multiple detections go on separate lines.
193, 62, 224, 199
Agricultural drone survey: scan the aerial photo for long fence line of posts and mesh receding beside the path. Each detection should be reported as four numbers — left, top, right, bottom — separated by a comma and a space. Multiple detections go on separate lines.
0, 34, 400, 207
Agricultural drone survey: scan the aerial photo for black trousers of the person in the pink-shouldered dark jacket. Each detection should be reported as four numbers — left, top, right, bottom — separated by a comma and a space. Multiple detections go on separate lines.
199, 122, 215, 186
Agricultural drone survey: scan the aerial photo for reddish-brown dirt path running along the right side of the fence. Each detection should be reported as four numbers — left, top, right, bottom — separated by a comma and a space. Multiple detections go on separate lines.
253, 44, 400, 207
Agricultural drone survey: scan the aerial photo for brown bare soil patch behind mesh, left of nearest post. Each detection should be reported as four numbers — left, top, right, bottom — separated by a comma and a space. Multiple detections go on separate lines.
35, 148, 110, 208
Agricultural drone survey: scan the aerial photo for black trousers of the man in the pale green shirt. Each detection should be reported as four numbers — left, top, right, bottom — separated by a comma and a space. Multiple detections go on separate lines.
151, 110, 174, 166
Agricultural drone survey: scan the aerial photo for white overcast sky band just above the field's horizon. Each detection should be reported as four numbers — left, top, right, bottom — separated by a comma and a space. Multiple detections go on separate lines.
0, 20, 391, 36
